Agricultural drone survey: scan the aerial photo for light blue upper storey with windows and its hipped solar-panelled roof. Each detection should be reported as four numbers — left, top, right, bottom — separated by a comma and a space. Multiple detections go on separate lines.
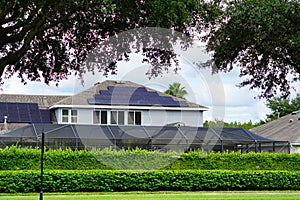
49, 81, 207, 126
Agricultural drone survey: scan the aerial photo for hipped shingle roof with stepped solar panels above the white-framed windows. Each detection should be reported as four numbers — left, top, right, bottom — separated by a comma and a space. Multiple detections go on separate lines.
51, 81, 207, 110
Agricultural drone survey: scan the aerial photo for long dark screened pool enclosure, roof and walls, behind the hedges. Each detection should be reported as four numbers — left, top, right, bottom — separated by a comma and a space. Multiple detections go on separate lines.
0, 124, 289, 152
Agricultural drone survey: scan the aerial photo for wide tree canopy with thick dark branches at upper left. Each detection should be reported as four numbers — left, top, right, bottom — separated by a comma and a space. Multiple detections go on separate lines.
0, 0, 204, 83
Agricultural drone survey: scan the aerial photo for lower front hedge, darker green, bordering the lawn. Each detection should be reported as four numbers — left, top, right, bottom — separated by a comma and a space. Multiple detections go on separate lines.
0, 170, 300, 193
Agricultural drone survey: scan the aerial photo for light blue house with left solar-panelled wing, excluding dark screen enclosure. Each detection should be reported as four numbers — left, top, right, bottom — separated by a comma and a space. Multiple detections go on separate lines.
0, 81, 207, 133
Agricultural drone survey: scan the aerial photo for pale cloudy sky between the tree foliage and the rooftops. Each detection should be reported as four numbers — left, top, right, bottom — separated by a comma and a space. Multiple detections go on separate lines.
1, 35, 300, 123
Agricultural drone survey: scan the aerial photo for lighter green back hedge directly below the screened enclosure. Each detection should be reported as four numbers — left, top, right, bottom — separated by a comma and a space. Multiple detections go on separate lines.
0, 147, 300, 171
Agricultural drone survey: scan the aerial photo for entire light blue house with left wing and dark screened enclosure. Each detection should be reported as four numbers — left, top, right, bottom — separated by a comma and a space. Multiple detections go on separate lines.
0, 81, 289, 152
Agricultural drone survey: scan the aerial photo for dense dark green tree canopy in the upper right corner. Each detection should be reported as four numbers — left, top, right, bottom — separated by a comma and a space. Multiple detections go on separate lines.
205, 0, 300, 97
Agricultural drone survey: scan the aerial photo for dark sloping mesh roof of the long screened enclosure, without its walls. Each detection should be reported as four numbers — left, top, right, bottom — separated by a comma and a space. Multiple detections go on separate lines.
2, 124, 275, 143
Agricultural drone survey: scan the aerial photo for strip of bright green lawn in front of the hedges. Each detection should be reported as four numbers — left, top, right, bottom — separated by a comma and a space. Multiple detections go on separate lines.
0, 192, 300, 200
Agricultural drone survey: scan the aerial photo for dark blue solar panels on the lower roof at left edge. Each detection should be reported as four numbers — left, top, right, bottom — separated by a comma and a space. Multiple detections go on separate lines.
0, 102, 51, 123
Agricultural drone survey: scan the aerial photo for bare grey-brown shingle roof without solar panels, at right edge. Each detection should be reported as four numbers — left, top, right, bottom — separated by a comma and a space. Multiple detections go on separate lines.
251, 110, 300, 143
